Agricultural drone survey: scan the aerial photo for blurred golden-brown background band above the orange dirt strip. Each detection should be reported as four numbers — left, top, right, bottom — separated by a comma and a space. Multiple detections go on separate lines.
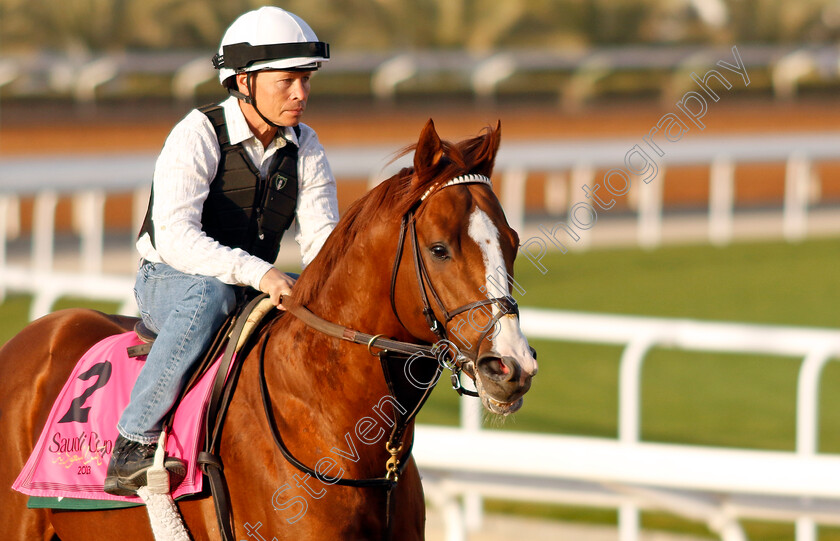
0, 0, 840, 108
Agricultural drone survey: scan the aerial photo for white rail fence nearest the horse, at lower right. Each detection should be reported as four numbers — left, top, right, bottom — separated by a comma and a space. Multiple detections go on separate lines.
414, 309, 840, 541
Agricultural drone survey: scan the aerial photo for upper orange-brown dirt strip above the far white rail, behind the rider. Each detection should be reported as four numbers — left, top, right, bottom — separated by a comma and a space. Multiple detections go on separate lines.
0, 97, 840, 155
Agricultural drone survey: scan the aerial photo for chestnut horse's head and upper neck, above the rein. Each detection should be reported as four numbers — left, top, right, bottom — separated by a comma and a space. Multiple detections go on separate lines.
294, 120, 537, 414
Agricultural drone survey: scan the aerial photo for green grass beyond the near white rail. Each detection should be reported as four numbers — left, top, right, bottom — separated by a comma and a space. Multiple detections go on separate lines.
0, 239, 840, 541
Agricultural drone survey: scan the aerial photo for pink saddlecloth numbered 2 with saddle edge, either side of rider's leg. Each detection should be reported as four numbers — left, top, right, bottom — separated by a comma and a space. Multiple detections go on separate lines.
13, 295, 274, 509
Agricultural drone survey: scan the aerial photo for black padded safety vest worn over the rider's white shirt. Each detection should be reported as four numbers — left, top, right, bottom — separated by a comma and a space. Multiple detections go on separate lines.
140, 105, 300, 263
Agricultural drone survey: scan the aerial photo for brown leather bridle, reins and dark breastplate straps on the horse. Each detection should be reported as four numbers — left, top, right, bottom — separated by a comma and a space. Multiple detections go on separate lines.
253, 175, 519, 539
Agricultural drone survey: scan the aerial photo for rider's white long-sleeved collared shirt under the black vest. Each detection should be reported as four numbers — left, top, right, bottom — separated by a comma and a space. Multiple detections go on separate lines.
137, 97, 338, 289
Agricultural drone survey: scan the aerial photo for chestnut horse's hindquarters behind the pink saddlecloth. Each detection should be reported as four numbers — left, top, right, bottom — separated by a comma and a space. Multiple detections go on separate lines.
0, 310, 134, 541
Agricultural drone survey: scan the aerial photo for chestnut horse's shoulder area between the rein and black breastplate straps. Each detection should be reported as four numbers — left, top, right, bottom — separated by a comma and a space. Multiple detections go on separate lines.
256, 315, 404, 477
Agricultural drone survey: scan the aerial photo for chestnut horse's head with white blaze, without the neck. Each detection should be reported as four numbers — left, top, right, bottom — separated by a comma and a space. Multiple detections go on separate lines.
391, 120, 537, 414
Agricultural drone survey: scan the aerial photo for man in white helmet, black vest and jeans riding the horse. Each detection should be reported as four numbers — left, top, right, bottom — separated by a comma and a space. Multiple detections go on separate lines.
105, 7, 338, 495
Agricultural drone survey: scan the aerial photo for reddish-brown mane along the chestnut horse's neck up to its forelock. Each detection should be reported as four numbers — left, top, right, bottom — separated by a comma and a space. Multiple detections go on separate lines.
294, 124, 495, 304
